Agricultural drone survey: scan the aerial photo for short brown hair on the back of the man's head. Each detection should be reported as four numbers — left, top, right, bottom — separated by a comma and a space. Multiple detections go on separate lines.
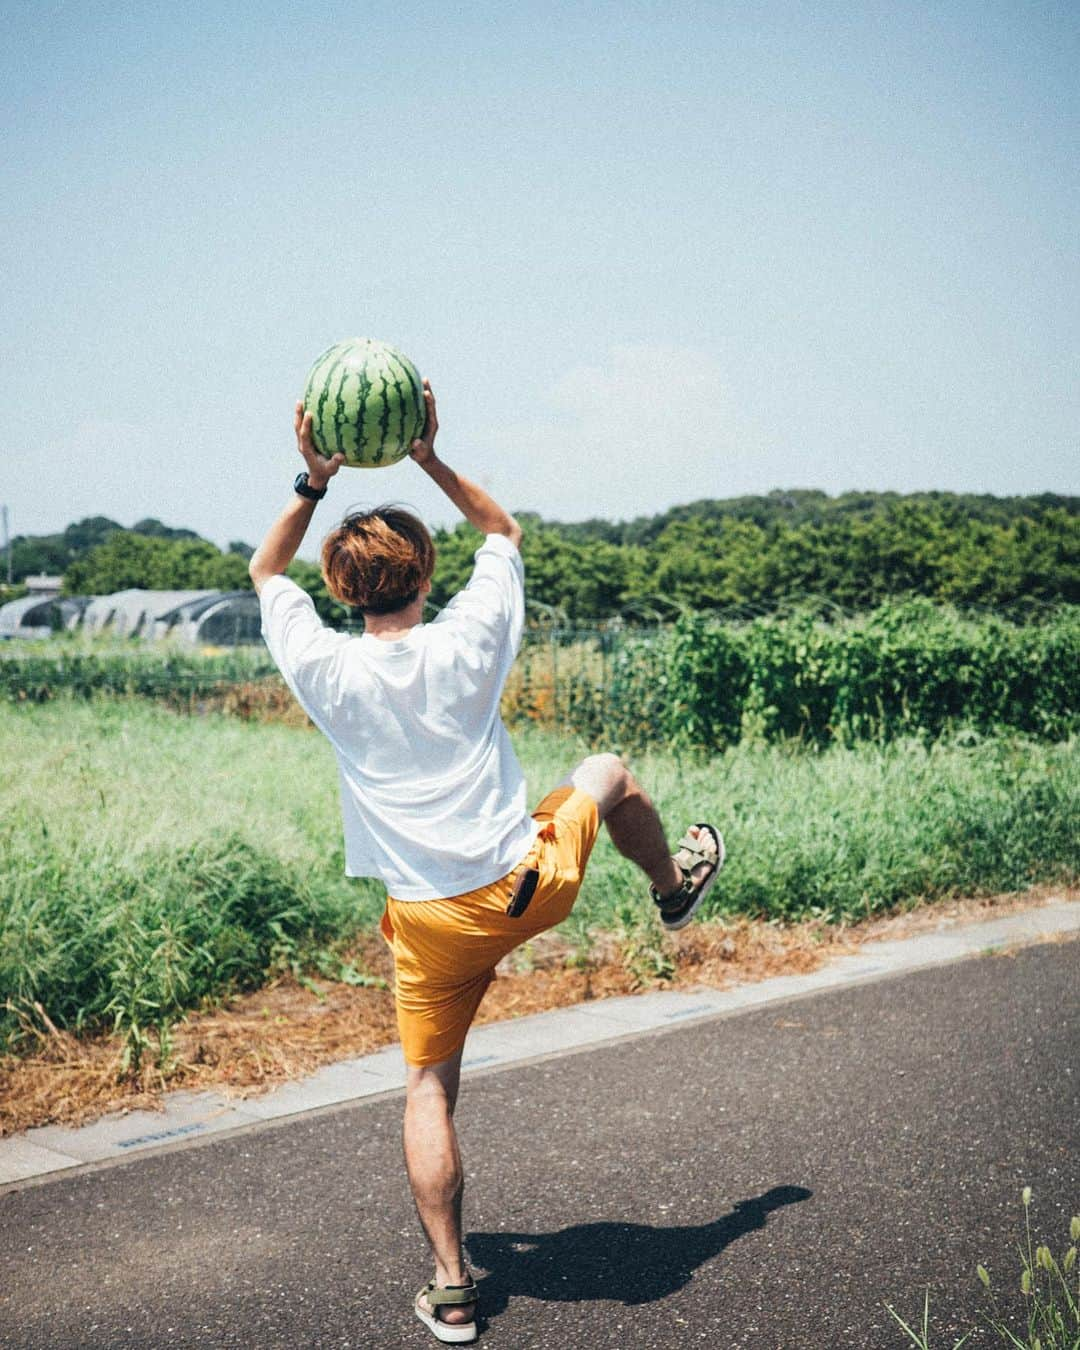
323, 506, 435, 614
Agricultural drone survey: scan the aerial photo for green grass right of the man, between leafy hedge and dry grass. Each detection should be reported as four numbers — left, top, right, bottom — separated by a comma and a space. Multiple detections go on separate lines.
570, 733, 1080, 929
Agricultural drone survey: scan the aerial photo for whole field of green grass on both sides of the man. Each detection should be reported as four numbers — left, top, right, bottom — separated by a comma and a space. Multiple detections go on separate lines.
0, 698, 1080, 1057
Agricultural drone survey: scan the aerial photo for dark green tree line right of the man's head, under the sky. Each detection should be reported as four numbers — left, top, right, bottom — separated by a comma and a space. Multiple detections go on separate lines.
432, 493, 1080, 624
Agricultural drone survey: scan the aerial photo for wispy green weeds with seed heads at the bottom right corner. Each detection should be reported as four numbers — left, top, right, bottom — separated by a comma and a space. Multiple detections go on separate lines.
886, 1185, 1080, 1350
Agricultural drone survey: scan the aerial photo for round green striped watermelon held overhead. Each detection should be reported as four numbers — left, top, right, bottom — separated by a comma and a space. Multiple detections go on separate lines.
304, 338, 425, 468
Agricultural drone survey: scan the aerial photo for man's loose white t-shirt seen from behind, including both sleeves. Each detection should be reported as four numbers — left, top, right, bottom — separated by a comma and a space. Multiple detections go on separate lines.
261, 535, 537, 900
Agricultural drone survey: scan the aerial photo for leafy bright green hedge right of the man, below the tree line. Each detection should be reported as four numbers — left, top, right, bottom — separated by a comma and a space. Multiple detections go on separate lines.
509, 601, 1080, 749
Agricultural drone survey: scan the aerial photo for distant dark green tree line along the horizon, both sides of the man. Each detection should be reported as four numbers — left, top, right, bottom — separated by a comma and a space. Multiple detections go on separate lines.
4, 491, 1080, 624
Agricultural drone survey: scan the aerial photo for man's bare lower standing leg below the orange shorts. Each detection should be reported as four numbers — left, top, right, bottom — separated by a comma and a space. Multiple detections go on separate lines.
405, 1050, 477, 1324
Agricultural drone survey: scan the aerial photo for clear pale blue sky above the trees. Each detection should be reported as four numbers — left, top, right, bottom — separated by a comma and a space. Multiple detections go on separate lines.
0, 0, 1080, 554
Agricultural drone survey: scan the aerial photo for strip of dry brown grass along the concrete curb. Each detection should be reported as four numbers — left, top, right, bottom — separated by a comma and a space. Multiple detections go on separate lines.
0, 888, 1080, 1134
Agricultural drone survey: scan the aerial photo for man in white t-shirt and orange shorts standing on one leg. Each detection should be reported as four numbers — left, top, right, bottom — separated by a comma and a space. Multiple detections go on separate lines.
250, 381, 724, 1343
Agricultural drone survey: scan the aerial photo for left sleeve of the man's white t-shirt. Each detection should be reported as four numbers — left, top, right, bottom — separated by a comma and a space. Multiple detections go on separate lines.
259, 575, 348, 728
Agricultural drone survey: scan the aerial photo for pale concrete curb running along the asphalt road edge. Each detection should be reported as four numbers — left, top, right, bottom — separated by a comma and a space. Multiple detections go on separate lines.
0, 900, 1080, 1195
